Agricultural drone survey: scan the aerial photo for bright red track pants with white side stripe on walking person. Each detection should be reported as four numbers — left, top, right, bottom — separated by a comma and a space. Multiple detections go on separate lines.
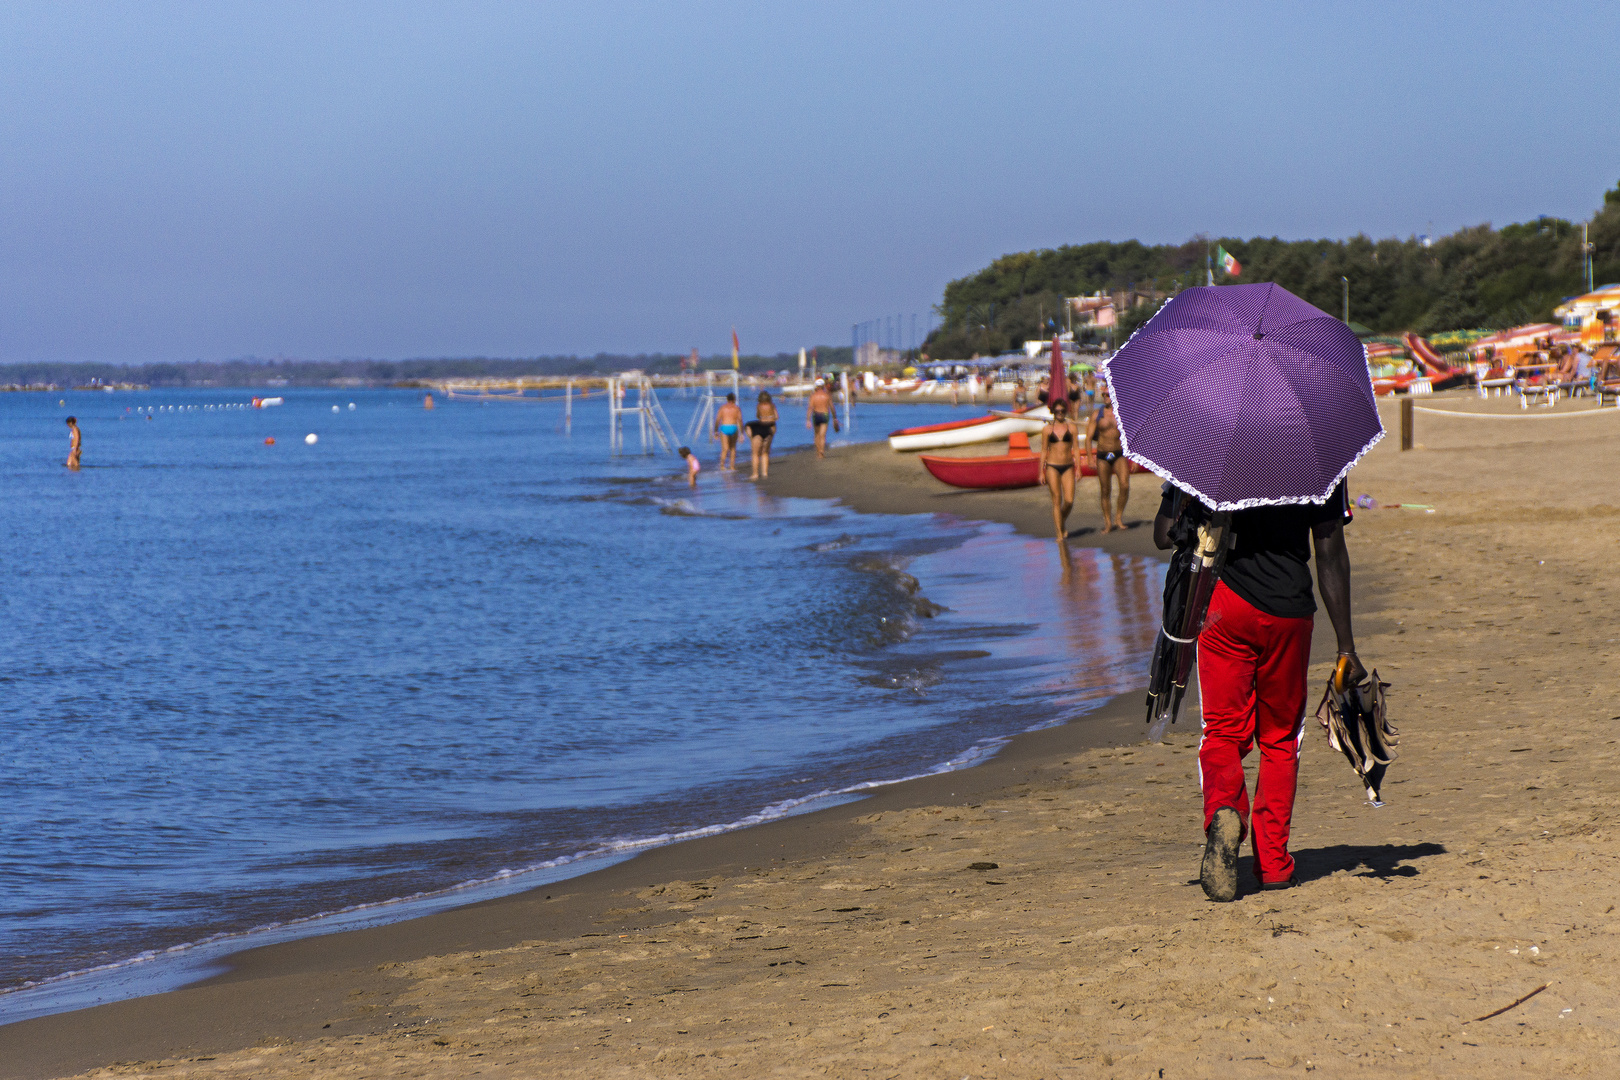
1199, 581, 1312, 884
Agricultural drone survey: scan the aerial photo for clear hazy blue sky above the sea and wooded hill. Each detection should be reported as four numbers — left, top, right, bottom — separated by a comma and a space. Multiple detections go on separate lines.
0, 0, 1620, 363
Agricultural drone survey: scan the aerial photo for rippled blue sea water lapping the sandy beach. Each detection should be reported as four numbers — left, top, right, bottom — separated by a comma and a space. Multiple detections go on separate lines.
0, 390, 1162, 1020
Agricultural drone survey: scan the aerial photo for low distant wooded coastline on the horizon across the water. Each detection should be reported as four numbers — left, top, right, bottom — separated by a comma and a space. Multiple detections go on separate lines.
0, 345, 851, 387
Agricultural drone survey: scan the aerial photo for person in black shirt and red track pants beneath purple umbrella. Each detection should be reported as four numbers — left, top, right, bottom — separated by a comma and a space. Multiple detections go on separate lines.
1153, 481, 1367, 902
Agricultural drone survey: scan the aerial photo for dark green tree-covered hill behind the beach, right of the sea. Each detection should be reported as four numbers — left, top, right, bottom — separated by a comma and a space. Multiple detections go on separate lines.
923, 186, 1620, 358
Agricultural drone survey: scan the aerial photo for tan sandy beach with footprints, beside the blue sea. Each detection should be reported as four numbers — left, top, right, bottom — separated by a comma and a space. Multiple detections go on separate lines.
9, 395, 1620, 1078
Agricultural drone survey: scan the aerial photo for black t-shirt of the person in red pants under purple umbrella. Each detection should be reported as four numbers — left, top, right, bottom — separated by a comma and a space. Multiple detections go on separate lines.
1158, 481, 1353, 619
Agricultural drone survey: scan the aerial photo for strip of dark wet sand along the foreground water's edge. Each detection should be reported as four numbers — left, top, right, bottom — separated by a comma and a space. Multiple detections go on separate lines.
0, 691, 1166, 1080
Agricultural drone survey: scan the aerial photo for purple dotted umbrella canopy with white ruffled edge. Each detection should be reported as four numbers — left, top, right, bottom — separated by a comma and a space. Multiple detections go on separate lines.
1103, 285, 1383, 510
